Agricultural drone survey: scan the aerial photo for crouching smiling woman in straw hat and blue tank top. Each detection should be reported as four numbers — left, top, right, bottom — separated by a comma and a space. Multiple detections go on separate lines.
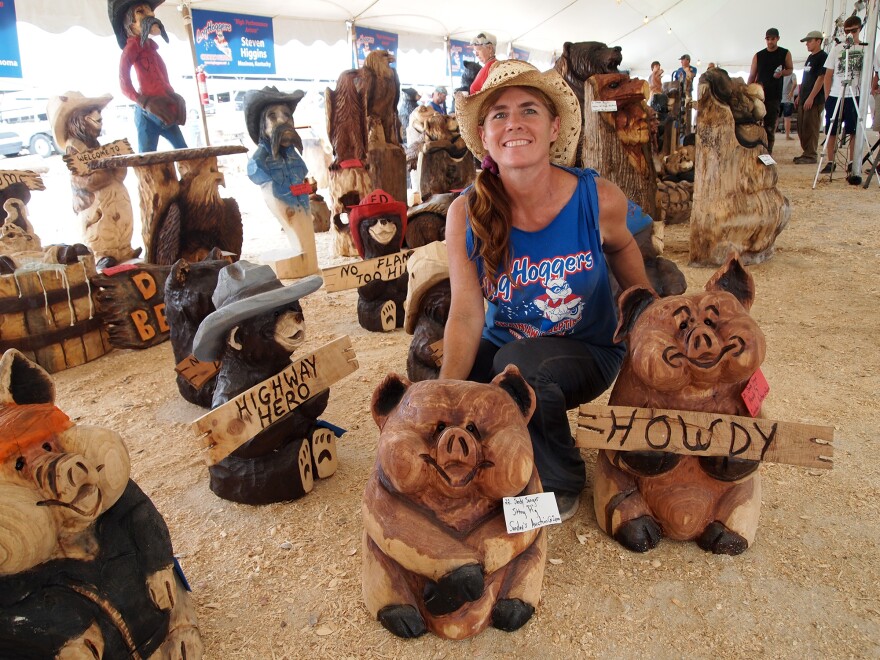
440, 60, 650, 519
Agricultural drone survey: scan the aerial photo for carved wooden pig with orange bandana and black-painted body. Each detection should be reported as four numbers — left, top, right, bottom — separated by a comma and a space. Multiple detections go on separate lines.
0, 350, 202, 659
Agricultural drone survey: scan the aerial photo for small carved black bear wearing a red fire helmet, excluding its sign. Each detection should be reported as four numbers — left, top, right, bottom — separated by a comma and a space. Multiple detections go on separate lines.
351, 190, 407, 332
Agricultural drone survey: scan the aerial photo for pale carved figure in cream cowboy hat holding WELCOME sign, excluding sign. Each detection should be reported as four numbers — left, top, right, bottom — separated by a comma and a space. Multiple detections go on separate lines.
48, 92, 141, 270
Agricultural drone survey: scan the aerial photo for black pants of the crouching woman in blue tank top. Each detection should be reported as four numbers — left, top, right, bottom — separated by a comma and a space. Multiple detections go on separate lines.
468, 337, 623, 493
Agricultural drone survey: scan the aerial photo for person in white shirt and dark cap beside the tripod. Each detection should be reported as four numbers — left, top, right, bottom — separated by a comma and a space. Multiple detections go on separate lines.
822, 16, 878, 174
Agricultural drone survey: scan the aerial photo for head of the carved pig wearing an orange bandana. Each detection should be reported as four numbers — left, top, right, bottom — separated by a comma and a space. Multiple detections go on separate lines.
0, 350, 130, 575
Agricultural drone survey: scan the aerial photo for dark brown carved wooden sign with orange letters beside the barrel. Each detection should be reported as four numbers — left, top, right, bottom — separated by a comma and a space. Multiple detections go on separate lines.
92, 264, 171, 348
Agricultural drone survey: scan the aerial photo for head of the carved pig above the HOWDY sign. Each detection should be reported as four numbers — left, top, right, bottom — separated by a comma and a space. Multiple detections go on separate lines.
615, 258, 766, 392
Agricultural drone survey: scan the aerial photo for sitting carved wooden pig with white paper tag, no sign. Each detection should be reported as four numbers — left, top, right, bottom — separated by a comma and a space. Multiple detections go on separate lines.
362, 366, 546, 639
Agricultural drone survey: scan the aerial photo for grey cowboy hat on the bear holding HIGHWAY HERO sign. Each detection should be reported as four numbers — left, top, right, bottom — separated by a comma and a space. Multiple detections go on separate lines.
193, 260, 324, 362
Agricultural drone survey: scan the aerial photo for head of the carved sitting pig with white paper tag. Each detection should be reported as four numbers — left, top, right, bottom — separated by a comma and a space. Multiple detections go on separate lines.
372, 366, 535, 511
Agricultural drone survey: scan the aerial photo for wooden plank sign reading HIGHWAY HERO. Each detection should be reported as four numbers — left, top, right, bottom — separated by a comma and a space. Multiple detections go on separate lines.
192, 336, 358, 466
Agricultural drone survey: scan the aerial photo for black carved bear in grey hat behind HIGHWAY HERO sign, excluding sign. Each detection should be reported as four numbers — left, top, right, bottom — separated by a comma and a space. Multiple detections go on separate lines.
192, 261, 337, 504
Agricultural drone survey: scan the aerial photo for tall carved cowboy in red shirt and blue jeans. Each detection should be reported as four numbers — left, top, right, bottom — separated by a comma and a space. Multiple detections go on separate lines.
107, 0, 186, 152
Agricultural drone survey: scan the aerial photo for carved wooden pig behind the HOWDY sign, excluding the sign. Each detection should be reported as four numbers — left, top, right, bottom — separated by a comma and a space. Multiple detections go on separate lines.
593, 257, 765, 555
